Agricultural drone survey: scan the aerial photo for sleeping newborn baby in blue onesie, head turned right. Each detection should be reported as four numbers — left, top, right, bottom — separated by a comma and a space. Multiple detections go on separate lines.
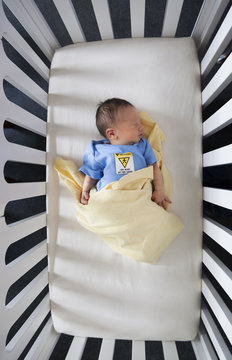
79, 98, 171, 209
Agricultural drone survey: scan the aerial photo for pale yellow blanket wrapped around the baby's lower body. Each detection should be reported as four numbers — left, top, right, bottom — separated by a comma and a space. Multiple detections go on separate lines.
54, 112, 183, 263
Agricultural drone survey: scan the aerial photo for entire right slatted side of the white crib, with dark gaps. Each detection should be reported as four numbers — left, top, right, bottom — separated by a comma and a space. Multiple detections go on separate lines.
200, 2, 232, 359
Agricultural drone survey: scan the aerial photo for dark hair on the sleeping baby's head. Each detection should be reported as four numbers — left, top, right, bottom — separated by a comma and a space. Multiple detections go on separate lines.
96, 98, 133, 138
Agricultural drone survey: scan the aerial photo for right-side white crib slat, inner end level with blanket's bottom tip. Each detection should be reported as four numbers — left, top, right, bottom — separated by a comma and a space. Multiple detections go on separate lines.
203, 249, 232, 298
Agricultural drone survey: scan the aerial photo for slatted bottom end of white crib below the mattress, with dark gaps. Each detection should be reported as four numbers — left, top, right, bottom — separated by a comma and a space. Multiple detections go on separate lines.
51, 335, 196, 360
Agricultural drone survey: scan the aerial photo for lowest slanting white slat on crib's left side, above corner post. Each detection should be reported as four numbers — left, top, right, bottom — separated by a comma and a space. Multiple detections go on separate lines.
6, 295, 50, 351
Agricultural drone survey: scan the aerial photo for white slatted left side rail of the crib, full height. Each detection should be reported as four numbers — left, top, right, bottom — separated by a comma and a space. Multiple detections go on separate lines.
0, 1, 58, 360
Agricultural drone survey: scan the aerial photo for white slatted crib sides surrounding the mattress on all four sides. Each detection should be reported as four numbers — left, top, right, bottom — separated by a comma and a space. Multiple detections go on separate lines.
0, 0, 232, 360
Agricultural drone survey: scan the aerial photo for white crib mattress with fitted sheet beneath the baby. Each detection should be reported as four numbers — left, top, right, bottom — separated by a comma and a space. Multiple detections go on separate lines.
47, 38, 202, 340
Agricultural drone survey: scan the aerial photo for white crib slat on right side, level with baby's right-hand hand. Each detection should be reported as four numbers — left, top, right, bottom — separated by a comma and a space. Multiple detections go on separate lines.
203, 187, 232, 210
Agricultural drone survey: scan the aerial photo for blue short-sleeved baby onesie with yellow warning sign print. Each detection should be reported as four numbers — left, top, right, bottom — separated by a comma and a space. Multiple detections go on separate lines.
79, 137, 157, 190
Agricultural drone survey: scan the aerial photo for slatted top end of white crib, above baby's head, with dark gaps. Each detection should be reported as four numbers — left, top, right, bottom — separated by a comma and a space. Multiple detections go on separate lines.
4, 0, 218, 46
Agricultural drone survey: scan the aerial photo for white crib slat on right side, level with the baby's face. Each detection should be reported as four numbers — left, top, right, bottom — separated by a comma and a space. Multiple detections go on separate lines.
203, 99, 232, 136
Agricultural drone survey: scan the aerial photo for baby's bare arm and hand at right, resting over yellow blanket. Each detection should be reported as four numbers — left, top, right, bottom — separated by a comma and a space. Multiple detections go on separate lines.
151, 163, 171, 210
